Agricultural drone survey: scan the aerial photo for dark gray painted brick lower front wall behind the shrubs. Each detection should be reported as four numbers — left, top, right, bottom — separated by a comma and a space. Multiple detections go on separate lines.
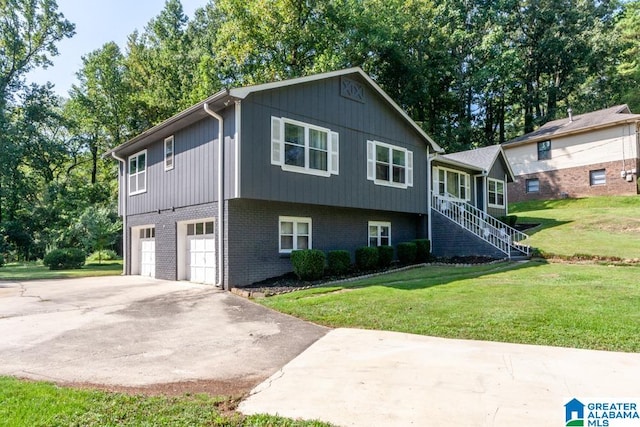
225, 199, 426, 287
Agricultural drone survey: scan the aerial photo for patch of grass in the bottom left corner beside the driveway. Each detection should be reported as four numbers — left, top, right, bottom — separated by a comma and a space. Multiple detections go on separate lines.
0, 377, 329, 427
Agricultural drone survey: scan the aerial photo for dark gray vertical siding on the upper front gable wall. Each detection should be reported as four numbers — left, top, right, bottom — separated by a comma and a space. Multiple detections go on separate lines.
241, 78, 427, 213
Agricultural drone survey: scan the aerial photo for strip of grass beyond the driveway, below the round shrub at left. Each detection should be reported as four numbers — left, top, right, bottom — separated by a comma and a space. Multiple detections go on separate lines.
0, 261, 122, 280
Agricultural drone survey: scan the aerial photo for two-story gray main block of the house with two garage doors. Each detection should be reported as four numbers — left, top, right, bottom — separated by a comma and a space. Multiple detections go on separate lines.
107, 68, 528, 289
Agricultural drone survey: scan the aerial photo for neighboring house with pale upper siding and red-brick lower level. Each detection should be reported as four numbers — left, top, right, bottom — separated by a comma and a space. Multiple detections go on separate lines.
503, 105, 640, 202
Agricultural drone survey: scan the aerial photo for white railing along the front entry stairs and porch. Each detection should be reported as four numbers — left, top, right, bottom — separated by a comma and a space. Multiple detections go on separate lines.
431, 194, 531, 259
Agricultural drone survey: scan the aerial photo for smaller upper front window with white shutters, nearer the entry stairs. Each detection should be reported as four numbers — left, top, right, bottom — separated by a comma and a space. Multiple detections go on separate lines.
367, 141, 413, 188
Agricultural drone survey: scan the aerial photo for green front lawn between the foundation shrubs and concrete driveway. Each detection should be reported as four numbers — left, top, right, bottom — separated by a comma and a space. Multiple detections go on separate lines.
258, 261, 640, 352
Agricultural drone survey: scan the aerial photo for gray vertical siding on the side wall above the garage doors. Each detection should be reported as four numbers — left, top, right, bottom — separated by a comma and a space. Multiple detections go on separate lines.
126, 108, 235, 215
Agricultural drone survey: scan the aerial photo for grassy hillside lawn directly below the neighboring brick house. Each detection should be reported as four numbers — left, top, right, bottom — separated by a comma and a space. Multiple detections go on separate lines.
509, 196, 640, 259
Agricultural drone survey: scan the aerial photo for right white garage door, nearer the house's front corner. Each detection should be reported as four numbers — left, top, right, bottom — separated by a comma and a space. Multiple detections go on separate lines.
187, 221, 216, 284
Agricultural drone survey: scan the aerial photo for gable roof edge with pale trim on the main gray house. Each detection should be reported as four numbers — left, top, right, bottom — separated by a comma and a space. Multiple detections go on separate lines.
104, 67, 443, 156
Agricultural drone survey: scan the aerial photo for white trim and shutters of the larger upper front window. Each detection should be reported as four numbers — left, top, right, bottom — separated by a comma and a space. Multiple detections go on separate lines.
271, 116, 340, 178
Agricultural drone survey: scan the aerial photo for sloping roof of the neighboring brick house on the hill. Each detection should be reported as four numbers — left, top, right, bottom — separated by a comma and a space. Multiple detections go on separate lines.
503, 104, 640, 146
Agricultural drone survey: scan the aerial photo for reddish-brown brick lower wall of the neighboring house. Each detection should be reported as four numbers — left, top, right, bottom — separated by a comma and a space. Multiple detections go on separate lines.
507, 159, 640, 202
